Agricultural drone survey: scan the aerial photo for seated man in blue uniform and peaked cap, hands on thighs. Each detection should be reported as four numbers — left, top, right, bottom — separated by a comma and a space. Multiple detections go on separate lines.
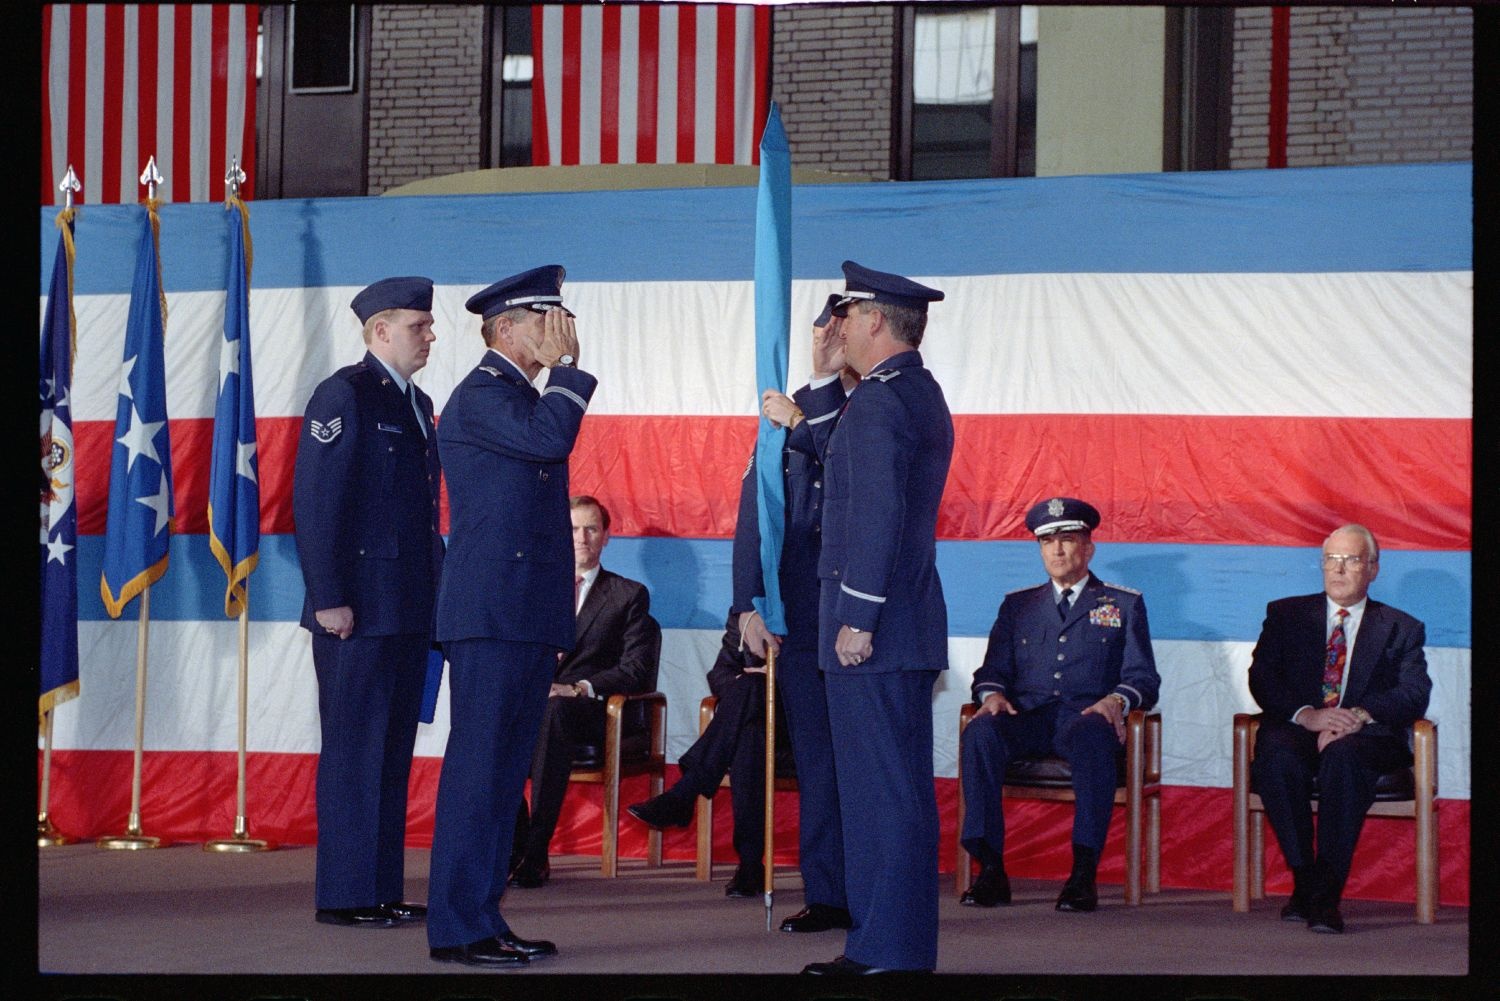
960, 497, 1161, 911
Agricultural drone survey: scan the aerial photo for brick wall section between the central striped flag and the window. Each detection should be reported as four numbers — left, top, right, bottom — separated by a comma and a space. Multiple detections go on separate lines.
771, 5, 900, 177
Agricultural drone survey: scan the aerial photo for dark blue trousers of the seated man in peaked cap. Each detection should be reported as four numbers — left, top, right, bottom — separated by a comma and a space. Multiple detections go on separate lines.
960, 702, 1124, 866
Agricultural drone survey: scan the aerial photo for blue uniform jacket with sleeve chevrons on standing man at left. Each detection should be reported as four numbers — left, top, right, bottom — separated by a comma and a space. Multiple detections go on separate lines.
293, 353, 443, 636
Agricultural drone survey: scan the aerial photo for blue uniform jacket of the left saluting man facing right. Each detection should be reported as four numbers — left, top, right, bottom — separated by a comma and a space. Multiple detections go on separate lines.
438, 351, 597, 650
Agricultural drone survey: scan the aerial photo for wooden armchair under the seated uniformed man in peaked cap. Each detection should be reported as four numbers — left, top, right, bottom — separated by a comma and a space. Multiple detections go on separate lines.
956, 702, 1161, 906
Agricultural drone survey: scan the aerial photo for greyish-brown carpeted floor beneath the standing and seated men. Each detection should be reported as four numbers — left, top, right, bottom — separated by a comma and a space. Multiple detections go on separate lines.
38, 843, 1472, 1001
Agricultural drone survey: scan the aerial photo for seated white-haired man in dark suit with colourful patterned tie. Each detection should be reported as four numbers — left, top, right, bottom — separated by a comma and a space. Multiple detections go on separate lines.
1250, 525, 1433, 933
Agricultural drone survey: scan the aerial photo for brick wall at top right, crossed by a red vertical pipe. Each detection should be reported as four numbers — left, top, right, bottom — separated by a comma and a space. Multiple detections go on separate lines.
1230, 8, 1473, 168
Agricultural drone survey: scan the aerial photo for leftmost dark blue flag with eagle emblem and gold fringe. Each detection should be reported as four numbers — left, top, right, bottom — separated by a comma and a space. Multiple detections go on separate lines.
38, 209, 78, 716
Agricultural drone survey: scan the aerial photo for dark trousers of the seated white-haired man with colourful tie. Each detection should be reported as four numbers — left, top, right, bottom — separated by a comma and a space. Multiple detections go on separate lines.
1250, 719, 1412, 903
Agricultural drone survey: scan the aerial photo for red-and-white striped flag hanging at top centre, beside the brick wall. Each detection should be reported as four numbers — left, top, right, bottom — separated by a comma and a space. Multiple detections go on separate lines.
531, 3, 771, 167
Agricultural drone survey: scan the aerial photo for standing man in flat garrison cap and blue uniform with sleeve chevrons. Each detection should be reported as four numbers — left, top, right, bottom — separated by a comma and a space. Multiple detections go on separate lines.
293, 278, 443, 927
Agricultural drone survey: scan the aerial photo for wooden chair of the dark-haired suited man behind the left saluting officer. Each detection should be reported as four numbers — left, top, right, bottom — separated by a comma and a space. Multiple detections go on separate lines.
570, 620, 666, 878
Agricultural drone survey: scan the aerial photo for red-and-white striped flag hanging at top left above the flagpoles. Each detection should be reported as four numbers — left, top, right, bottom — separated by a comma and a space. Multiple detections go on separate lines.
42, 3, 260, 204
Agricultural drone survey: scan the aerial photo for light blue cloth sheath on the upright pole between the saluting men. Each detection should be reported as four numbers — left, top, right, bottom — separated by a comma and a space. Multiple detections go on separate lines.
755, 101, 792, 636
